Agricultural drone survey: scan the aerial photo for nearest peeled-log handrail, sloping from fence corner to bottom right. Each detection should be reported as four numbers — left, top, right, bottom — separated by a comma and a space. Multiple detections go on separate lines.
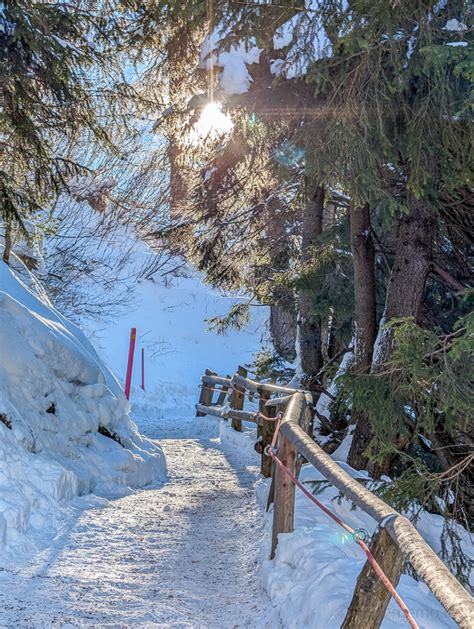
280, 393, 474, 629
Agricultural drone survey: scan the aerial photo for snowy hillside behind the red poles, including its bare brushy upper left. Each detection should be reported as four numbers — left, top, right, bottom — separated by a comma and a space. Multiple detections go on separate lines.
45, 203, 269, 418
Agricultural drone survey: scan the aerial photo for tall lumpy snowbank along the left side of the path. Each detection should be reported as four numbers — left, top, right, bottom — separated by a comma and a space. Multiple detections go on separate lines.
0, 263, 166, 568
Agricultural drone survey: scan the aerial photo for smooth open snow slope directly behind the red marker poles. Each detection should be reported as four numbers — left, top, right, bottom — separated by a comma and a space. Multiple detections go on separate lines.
84, 258, 268, 416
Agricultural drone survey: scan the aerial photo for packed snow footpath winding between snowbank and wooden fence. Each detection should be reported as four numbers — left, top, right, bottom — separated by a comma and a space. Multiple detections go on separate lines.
0, 418, 276, 628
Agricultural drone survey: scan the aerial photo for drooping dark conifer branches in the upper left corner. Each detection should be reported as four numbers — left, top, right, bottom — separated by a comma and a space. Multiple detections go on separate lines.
0, 0, 137, 260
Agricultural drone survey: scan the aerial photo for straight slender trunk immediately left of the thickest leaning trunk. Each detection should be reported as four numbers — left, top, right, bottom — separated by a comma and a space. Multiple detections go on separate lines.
347, 205, 376, 469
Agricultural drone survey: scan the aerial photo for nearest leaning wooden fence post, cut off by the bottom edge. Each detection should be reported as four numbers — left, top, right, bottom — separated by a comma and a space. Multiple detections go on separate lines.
341, 528, 403, 629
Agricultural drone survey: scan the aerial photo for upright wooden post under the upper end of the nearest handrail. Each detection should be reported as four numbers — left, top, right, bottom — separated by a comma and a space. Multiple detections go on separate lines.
270, 433, 296, 559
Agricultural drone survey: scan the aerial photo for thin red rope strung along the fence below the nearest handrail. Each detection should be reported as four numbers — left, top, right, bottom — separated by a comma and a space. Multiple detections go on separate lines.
266, 418, 420, 629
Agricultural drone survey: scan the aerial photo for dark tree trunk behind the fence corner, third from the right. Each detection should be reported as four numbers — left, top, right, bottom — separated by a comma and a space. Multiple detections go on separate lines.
298, 178, 324, 386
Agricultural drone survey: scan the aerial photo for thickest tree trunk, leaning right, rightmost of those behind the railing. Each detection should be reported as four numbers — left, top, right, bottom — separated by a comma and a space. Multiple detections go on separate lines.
349, 199, 436, 477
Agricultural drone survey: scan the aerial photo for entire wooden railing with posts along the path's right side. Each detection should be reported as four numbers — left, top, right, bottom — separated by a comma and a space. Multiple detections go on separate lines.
196, 367, 474, 629
